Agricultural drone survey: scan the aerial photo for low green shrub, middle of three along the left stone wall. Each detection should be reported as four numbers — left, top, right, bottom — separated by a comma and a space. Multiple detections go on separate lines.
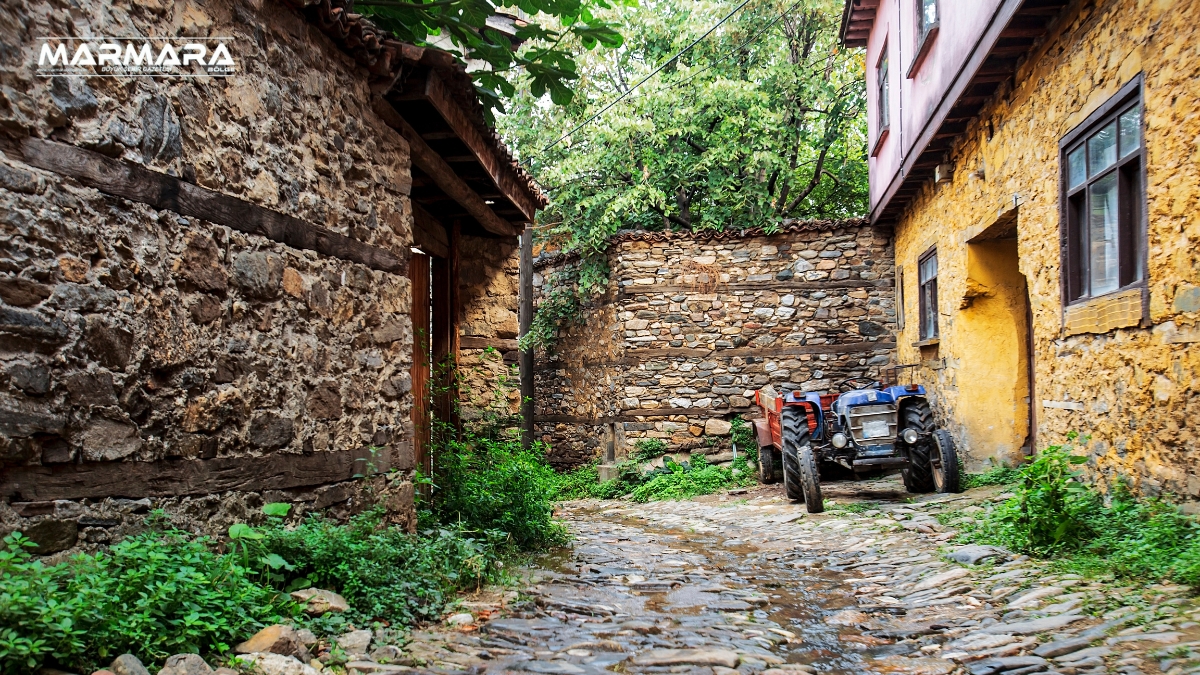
263, 510, 506, 631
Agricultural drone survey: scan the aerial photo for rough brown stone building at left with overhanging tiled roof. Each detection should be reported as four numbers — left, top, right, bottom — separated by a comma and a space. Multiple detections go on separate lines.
0, 0, 544, 552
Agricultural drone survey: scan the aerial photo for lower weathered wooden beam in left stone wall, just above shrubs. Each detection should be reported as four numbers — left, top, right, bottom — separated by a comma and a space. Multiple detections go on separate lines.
0, 442, 406, 502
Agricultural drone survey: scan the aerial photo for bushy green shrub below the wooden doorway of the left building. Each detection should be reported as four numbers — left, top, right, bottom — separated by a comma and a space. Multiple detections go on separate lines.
424, 427, 569, 550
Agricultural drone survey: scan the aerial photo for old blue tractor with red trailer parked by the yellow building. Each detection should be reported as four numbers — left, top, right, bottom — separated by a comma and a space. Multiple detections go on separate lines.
754, 367, 962, 513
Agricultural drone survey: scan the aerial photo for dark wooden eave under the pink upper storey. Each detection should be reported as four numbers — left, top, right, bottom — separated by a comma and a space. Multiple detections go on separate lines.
868, 0, 1070, 226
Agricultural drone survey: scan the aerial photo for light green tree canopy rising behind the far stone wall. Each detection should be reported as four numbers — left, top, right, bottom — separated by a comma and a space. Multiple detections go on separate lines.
498, 0, 868, 342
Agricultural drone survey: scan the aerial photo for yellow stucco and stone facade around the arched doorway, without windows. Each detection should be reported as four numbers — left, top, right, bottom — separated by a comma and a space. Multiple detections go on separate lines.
895, 0, 1200, 498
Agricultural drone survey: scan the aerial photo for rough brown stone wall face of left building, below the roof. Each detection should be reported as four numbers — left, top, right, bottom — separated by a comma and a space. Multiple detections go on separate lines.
0, 0, 412, 543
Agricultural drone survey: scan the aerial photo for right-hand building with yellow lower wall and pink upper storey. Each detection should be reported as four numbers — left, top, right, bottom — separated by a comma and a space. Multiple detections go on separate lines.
842, 0, 1200, 498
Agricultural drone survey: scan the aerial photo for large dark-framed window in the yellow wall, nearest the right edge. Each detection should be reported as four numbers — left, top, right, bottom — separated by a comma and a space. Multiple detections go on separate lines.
1062, 79, 1146, 304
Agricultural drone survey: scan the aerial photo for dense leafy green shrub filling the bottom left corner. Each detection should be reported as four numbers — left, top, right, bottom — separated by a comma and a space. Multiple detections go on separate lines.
0, 531, 298, 673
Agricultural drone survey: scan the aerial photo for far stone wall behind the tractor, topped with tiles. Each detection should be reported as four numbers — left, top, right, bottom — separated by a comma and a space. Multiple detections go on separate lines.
534, 221, 895, 466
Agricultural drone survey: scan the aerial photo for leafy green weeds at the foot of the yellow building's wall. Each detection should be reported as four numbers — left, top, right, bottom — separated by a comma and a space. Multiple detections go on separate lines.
962, 435, 1200, 587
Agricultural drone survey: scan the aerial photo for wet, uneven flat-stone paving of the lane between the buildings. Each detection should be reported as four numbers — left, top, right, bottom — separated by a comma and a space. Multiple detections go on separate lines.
393, 479, 1200, 675
